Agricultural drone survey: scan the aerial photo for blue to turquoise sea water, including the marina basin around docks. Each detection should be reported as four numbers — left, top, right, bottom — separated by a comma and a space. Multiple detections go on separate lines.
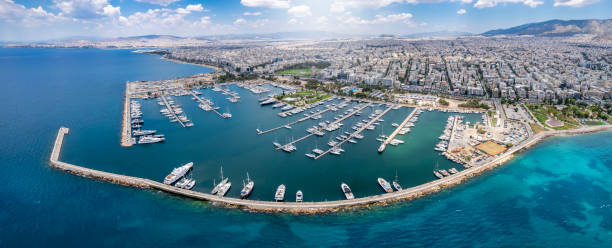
0, 48, 612, 247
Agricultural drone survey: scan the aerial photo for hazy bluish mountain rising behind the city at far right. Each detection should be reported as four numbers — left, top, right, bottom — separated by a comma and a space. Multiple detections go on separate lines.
482, 19, 612, 40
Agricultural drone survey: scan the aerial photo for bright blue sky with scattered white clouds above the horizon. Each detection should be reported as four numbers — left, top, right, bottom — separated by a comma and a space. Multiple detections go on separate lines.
0, 0, 612, 41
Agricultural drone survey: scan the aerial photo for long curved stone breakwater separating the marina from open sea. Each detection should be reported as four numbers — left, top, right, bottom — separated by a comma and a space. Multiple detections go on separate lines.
49, 125, 612, 214
